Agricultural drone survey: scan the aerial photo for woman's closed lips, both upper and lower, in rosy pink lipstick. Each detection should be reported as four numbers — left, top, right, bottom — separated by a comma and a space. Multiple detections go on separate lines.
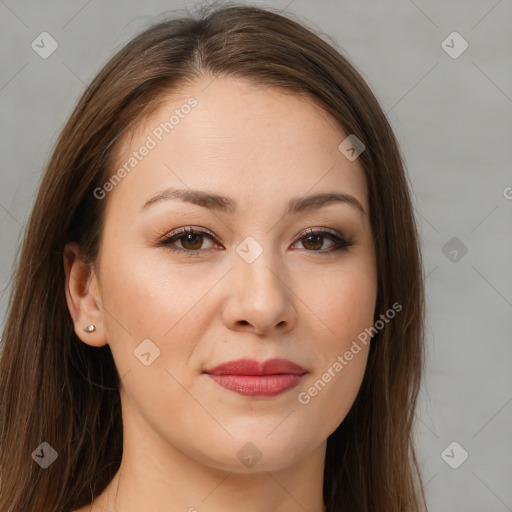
204, 359, 307, 397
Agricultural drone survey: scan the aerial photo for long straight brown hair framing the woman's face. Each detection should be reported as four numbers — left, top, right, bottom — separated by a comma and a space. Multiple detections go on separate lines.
0, 5, 426, 512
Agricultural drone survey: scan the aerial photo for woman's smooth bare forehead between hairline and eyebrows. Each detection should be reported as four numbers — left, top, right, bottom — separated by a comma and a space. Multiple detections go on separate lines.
105, 77, 367, 218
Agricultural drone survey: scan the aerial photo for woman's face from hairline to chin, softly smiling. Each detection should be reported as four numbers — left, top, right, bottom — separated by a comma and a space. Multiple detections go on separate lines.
74, 77, 377, 472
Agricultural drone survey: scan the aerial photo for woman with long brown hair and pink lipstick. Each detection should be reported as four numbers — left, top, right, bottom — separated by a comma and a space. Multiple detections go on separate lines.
0, 6, 426, 512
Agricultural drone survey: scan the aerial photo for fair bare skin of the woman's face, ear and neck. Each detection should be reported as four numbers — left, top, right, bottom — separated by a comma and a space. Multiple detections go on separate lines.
64, 76, 377, 512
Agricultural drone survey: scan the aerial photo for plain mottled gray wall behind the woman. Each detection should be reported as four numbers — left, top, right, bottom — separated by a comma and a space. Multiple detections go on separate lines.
0, 0, 512, 512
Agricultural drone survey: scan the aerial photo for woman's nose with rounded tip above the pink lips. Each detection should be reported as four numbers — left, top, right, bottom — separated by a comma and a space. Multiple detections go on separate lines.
222, 251, 297, 336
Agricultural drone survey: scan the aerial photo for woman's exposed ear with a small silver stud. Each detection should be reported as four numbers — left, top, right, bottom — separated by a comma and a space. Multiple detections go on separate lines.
64, 242, 108, 347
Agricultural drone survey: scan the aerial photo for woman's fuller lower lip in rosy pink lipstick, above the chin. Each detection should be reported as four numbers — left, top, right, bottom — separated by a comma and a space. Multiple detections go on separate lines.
208, 373, 303, 396
